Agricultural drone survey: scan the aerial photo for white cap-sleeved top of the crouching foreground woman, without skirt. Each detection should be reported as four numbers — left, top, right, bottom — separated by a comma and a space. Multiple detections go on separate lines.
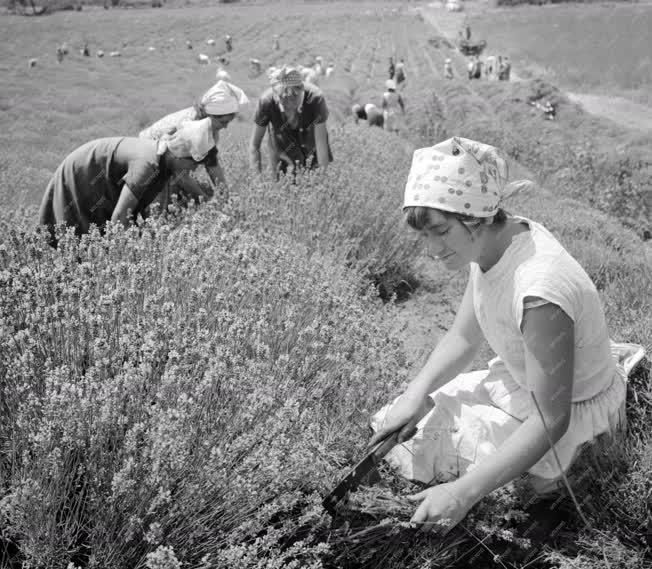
470, 216, 616, 403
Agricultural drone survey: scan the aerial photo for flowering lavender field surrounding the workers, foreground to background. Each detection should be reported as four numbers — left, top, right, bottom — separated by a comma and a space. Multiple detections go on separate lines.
0, 3, 652, 569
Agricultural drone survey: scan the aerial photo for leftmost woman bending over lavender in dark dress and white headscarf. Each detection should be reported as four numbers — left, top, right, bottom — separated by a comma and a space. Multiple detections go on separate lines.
39, 123, 214, 246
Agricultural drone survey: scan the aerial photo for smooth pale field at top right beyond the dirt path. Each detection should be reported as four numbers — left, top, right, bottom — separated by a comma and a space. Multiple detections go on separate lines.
460, 3, 652, 105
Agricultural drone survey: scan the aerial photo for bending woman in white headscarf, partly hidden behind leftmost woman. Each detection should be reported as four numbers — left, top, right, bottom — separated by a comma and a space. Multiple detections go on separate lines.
138, 79, 249, 203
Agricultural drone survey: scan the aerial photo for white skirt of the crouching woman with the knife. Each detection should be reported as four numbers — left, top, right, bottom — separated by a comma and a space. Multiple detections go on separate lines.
371, 342, 645, 494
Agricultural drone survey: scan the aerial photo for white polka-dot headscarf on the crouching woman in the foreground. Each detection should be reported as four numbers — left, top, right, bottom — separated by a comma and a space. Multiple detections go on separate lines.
403, 136, 533, 217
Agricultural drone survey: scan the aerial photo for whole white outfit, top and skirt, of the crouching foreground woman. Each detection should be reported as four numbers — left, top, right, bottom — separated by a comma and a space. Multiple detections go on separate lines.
372, 216, 644, 486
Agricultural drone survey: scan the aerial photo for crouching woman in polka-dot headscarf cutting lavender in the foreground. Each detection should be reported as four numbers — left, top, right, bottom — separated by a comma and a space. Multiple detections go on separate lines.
371, 137, 643, 531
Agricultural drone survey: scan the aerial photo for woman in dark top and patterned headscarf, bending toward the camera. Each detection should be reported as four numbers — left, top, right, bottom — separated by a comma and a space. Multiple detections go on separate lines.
249, 65, 333, 175
